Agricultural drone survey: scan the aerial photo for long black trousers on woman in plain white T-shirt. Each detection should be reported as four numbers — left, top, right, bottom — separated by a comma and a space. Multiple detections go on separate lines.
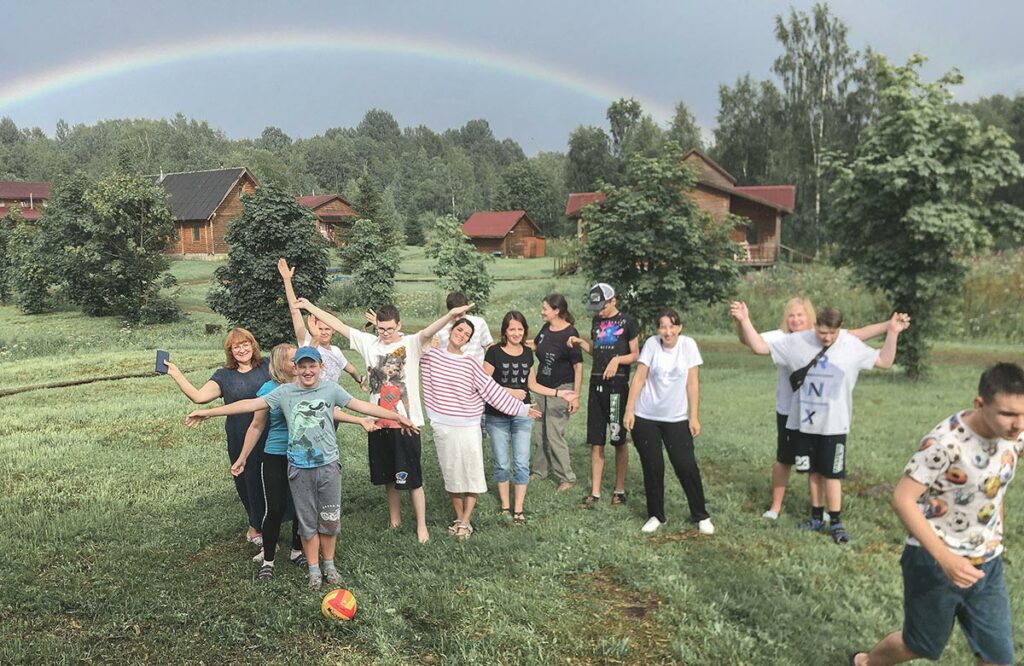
633, 416, 710, 523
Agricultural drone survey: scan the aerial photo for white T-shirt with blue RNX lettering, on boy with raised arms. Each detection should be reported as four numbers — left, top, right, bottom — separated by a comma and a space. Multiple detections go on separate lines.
768, 330, 879, 434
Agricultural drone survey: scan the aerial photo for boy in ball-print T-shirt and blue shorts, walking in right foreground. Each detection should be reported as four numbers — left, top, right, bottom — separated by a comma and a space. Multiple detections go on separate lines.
850, 363, 1024, 666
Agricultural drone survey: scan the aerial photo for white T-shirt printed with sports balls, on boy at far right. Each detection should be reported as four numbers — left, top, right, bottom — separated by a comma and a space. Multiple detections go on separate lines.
903, 412, 1024, 564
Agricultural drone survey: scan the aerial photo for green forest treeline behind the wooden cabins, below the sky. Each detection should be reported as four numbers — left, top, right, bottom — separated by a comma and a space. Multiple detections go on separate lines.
0, 4, 1024, 252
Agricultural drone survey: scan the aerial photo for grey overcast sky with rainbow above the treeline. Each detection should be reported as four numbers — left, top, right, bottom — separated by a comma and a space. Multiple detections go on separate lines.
0, 0, 1024, 154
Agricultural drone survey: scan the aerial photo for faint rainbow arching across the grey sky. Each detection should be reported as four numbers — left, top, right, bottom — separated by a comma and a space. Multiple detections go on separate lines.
0, 29, 673, 122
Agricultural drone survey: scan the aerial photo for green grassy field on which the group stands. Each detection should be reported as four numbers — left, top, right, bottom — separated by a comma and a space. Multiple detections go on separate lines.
0, 252, 1024, 664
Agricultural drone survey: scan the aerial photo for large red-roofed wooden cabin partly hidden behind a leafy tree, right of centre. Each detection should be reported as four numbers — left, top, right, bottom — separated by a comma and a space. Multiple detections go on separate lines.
565, 149, 797, 266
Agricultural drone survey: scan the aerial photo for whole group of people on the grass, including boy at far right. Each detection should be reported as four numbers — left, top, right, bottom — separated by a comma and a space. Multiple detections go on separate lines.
168, 259, 1024, 665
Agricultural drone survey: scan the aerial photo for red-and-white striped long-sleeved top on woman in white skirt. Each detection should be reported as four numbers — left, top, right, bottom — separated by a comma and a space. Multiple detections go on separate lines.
420, 349, 529, 425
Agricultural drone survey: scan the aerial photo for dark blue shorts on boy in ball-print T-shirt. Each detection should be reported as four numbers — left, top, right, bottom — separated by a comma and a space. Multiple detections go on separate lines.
900, 546, 1014, 664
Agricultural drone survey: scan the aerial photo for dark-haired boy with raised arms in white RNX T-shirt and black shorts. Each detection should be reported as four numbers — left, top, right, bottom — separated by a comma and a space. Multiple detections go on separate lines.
737, 307, 909, 545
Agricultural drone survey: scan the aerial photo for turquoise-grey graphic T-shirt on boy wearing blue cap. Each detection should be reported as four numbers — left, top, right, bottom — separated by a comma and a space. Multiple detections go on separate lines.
261, 381, 352, 468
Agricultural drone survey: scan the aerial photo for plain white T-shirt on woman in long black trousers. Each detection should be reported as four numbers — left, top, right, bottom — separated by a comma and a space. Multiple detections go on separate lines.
633, 335, 703, 423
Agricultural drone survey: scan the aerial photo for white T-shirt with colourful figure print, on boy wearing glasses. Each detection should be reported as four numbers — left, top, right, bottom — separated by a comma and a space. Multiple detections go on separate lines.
349, 329, 423, 427
